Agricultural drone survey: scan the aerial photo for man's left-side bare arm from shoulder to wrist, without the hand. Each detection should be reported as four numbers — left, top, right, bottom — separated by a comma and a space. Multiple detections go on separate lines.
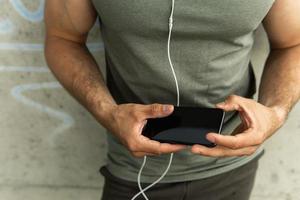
45, 0, 116, 128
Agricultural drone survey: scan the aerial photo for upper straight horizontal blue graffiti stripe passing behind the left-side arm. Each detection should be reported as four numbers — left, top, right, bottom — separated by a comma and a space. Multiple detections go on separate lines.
0, 42, 104, 51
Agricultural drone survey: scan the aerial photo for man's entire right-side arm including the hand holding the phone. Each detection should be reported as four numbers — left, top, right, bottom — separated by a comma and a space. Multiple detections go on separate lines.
192, 0, 300, 157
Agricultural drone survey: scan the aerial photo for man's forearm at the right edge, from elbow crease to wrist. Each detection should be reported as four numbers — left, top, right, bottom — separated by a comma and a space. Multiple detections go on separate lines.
258, 45, 300, 121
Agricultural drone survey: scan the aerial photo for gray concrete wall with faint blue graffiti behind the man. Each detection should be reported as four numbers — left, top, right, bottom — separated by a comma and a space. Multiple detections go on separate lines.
0, 0, 300, 200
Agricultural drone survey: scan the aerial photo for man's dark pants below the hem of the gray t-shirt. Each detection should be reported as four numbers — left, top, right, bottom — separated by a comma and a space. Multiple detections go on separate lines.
100, 153, 260, 200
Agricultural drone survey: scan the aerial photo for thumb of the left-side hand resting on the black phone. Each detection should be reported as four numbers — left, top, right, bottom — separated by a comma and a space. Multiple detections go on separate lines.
144, 103, 174, 118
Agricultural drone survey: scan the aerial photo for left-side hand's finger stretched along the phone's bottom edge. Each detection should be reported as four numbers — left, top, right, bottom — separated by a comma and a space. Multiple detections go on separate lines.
139, 135, 187, 155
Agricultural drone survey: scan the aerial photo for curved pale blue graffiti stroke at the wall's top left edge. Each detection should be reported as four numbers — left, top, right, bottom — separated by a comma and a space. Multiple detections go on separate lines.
10, 0, 45, 22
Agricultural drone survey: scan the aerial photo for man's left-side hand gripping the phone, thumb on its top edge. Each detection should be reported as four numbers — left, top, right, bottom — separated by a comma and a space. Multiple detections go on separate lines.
108, 103, 186, 157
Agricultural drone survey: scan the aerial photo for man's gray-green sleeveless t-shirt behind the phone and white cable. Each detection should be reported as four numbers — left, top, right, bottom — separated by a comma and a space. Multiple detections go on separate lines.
93, 0, 275, 182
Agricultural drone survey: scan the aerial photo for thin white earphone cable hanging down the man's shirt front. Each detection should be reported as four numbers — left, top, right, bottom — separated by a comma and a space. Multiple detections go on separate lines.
131, 0, 179, 200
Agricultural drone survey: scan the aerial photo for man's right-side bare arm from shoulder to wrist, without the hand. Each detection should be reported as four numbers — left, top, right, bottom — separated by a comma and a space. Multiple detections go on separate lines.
258, 0, 300, 122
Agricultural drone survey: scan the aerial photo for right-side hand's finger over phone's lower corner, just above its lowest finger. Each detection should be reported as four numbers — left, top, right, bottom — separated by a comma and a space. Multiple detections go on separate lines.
206, 129, 263, 149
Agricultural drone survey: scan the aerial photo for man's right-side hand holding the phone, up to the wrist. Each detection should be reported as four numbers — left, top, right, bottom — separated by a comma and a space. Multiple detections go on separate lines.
191, 95, 285, 157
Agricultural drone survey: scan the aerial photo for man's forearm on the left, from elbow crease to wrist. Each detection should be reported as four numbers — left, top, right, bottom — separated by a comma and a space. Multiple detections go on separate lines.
45, 36, 116, 127
